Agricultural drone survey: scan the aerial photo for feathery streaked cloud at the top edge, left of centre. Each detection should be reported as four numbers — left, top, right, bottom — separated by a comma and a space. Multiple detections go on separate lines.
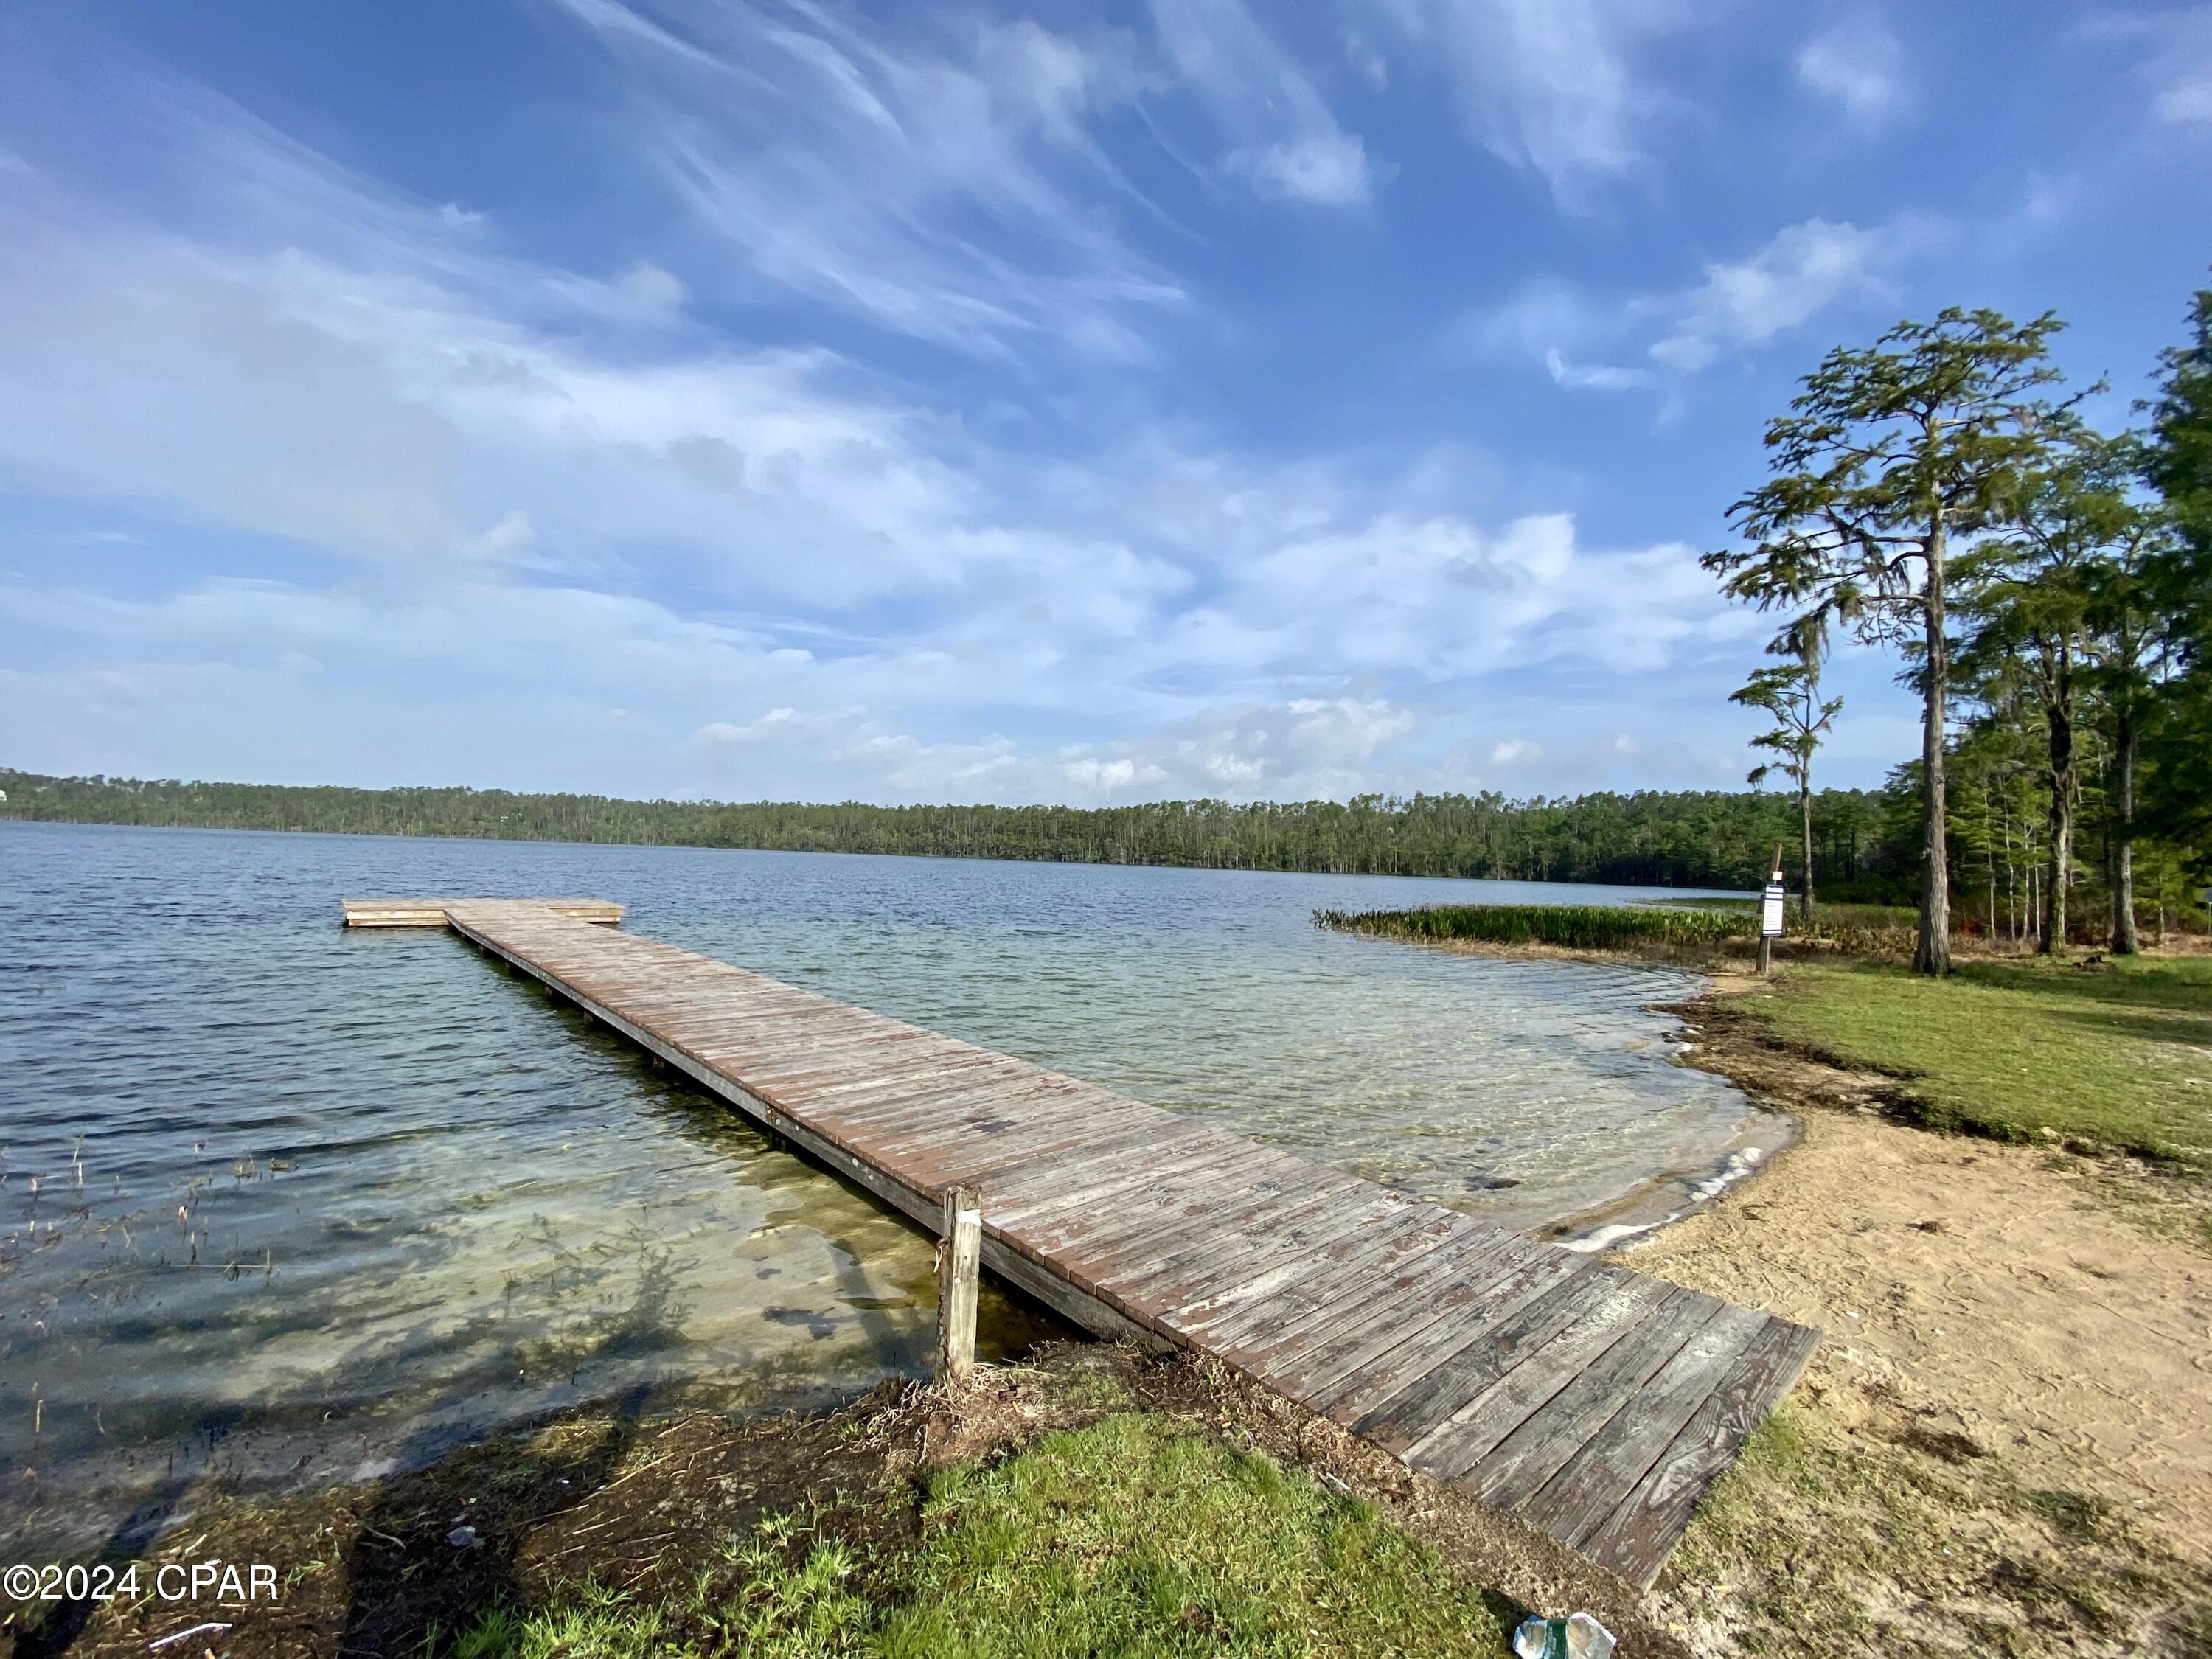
544, 0, 1181, 358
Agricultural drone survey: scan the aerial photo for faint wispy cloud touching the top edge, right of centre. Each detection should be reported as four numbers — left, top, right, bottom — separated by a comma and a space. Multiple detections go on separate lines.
1371, 0, 1721, 210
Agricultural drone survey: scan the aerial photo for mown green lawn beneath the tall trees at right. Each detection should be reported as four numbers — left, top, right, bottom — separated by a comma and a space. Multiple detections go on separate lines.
1759, 958, 2212, 1172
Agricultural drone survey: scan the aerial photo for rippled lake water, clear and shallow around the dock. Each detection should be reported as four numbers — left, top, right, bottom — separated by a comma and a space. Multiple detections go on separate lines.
0, 823, 1772, 1553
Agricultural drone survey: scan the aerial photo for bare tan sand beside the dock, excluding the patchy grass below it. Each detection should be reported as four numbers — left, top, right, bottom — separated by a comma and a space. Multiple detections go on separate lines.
1621, 975, 2212, 1564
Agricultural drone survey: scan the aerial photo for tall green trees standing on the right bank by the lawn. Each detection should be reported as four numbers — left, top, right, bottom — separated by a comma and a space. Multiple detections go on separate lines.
1705, 288, 2212, 973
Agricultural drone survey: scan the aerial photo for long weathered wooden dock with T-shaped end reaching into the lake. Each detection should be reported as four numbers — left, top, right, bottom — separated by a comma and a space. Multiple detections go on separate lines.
347, 900, 1816, 1586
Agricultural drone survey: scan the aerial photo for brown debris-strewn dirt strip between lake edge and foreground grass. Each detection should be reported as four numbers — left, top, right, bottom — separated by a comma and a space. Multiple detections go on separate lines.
0, 1343, 1686, 1659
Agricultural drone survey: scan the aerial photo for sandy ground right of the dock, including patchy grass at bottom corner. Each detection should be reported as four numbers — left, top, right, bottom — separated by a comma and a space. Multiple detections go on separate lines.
1619, 973, 2212, 1652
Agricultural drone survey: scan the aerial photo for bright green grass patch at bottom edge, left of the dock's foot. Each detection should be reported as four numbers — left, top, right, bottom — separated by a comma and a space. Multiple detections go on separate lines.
449, 1413, 1511, 1659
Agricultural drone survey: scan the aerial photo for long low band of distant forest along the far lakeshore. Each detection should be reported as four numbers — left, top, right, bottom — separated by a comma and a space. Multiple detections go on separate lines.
0, 768, 1918, 896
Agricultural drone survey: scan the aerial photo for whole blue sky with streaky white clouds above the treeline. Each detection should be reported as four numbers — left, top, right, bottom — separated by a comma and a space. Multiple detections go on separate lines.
0, 0, 2212, 805
